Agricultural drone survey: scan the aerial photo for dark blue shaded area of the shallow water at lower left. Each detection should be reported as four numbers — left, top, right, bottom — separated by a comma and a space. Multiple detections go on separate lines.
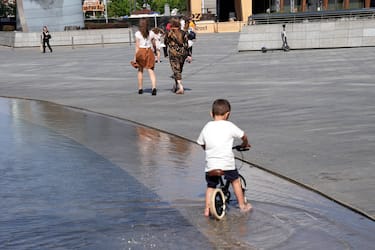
0, 98, 211, 249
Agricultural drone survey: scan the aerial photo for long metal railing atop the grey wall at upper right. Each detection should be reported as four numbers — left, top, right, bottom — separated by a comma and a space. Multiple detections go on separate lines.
248, 8, 375, 25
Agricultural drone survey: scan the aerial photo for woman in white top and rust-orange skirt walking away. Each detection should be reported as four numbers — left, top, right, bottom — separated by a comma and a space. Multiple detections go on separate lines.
134, 18, 157, 95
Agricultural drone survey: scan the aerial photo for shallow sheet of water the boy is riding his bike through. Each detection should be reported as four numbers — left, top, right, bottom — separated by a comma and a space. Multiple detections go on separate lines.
0, 98, 375, 249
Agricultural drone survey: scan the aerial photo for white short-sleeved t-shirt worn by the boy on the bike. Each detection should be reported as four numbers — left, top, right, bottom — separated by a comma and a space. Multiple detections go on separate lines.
197, 120, 244, 172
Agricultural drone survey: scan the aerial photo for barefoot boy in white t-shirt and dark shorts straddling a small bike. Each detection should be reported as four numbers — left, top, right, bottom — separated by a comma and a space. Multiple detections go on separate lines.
197, 99, 252, 217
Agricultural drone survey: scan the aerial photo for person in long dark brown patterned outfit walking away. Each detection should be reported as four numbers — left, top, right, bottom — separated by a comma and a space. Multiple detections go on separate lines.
164, 17, 191, 94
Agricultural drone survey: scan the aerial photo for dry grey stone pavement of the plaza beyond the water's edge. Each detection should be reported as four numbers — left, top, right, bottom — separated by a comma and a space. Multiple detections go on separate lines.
0, 33, 375, 219
